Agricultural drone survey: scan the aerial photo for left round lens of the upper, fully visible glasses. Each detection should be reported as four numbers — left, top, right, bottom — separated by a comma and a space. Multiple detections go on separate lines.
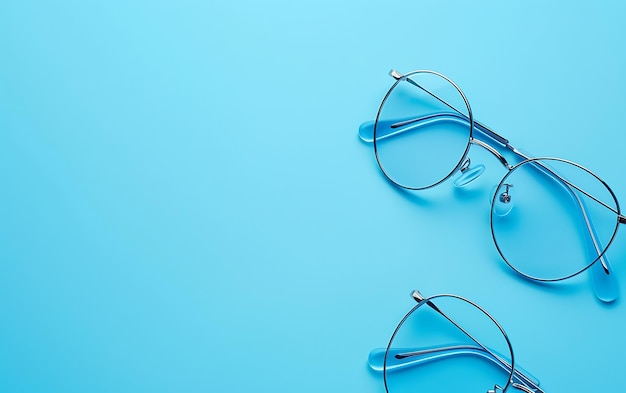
374, 71, 473, 190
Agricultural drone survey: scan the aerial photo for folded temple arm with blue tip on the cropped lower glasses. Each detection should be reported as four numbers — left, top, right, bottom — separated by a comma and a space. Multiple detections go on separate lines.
368, 345, 542, 392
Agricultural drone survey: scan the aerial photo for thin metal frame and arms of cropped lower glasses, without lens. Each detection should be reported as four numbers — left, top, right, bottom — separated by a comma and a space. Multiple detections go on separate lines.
368, 290, 544, 393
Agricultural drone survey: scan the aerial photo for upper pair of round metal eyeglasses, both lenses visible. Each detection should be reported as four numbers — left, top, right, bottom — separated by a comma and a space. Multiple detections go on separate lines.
359, 70, 626, 302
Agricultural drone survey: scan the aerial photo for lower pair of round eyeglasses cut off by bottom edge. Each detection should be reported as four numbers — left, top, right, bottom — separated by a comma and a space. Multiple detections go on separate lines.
369, 291, 543, 393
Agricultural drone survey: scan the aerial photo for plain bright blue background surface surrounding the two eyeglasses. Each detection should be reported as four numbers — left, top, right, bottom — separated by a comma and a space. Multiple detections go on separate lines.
0, 0, 626, 393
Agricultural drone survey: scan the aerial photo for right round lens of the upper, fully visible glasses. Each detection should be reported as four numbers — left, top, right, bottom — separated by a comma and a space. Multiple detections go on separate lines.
491, 158, 619, 281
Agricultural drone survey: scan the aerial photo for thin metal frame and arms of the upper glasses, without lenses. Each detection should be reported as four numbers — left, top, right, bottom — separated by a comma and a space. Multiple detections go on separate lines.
359, 70, 626, 302
